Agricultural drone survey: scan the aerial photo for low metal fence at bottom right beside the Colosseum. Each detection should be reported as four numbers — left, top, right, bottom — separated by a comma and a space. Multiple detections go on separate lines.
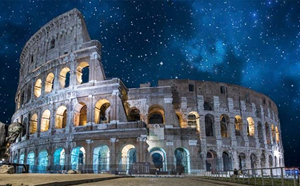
204, 167, 300, 186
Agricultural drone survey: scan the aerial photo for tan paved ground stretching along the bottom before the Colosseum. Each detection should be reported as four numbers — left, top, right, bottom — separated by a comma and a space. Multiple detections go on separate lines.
0, 174, 248, 186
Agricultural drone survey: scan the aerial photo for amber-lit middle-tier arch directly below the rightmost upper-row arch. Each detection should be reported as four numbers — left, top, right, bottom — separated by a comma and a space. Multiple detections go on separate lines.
74, 102, 87, 126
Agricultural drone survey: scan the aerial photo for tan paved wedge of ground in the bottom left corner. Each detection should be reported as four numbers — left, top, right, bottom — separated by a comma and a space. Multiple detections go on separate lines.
0, 174, 115, 186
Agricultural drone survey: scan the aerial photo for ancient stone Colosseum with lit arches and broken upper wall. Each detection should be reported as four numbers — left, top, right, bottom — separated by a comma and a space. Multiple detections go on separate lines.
10, 9, 284, 174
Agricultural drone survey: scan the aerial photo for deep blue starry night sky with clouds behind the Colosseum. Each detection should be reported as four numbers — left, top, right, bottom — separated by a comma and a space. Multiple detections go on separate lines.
0, 0, 300, 166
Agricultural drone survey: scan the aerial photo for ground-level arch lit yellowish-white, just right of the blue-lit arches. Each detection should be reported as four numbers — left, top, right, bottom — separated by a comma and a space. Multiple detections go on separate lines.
121, 144, 136, 172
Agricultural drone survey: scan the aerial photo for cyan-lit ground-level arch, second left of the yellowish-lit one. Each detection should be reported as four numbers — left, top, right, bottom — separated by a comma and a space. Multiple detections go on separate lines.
71, 147, 85, 171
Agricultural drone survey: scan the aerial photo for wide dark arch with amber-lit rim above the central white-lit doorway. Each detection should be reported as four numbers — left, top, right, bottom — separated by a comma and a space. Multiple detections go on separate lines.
148, 105, 165, 124
